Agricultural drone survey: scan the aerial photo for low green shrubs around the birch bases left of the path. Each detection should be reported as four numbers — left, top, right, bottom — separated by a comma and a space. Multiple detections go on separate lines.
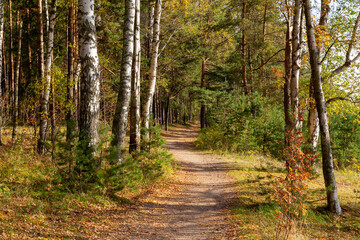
51, 123, 173, 196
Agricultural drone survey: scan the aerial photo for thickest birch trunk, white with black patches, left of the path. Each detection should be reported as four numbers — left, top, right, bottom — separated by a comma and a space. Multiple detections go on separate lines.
78, 0, 100, 154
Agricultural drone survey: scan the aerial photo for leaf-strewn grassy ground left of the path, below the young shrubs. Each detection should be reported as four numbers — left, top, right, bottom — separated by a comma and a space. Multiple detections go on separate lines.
0, 128, 176, 239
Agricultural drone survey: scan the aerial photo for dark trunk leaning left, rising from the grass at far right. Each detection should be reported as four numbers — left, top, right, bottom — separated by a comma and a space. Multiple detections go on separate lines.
303, 0, 342, 215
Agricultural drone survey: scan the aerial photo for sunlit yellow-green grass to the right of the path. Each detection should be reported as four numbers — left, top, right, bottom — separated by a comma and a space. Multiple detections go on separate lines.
211, 153, 360, 239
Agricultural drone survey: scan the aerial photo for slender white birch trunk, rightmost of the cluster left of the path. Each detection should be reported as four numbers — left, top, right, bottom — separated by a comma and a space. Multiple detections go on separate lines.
142, 0, 162, 140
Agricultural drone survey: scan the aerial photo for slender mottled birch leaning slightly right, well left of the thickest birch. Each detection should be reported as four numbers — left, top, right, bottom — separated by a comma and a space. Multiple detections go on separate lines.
38, 0, 57, 154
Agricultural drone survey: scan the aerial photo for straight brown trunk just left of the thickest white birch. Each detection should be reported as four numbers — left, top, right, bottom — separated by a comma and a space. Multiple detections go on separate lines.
66, 3, 76, 144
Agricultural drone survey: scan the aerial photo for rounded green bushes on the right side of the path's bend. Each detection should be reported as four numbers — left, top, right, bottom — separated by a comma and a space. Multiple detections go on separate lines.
196, 91, 284, 157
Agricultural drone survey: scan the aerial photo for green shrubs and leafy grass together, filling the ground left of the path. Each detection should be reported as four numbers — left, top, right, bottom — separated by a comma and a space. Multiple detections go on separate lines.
0, 125, 176, 239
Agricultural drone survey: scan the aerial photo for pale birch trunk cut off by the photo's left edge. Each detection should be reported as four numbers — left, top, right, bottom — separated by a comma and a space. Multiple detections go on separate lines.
0, 0, 5, 145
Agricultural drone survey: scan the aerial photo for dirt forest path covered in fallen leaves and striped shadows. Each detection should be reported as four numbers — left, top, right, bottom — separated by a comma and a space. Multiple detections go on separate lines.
116, 126, 235, 240
